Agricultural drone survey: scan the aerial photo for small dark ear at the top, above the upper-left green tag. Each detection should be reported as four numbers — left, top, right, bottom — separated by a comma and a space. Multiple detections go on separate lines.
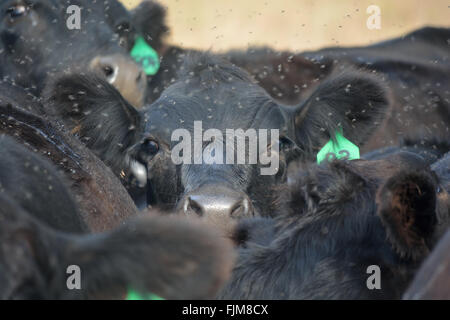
131, 0, 169, 52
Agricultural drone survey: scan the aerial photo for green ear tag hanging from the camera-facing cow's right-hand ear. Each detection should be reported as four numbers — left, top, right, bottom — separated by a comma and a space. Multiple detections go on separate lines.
317, 132, 359, 163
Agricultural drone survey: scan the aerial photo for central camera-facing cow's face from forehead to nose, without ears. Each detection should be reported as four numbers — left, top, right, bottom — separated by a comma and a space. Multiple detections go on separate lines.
137, 74, 288, 229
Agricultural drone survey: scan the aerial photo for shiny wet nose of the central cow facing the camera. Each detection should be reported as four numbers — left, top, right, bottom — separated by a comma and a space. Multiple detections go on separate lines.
182, 185, 253, 220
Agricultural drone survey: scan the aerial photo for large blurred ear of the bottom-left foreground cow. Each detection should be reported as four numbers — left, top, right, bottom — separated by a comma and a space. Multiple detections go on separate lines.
61, 216, 234, 299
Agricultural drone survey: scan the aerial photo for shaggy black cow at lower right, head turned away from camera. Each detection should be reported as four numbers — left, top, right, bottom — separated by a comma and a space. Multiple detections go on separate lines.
218, 151, 450, 299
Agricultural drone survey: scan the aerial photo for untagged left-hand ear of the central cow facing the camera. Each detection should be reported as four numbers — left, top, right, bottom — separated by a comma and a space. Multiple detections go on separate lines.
44, 74, 141, 172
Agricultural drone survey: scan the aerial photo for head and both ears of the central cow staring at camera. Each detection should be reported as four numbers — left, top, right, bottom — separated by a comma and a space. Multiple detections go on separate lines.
45, 54, 389, 230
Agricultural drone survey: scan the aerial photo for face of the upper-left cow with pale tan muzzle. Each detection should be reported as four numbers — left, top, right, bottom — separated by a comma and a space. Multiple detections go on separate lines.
0, 0, 146, 107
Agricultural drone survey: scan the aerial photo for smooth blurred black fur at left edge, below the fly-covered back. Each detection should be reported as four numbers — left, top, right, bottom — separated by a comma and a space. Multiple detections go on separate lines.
0, 136, 87, 233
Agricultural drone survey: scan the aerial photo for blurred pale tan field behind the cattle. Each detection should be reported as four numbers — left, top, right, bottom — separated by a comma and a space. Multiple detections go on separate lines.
122, 0, 450, 51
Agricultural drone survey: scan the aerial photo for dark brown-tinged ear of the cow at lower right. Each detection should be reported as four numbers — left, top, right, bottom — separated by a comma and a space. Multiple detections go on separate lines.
377, 170, 437, 260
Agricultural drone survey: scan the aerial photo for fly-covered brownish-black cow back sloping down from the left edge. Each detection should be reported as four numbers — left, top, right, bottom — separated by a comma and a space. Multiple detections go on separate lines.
0, 83, 137, 232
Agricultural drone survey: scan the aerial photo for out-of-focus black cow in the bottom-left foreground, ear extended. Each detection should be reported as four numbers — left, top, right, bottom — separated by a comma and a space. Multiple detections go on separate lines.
0, 193, 233, 300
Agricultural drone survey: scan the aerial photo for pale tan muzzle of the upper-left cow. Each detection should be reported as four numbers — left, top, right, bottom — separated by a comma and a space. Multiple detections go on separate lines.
90, 54, 147, 108
